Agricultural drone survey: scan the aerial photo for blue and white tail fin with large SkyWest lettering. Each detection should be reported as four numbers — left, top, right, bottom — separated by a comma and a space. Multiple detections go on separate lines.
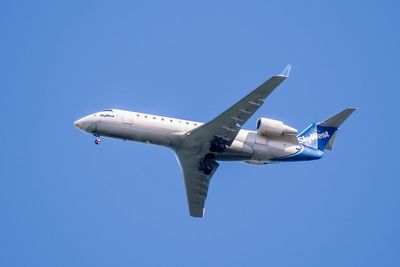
297, 108, 356, 150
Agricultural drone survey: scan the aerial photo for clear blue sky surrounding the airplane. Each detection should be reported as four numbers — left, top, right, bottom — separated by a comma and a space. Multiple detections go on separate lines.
0, 0, 400, 267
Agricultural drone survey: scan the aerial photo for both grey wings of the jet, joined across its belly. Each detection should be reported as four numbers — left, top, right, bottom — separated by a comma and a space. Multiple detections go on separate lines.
176, 65, 290, 217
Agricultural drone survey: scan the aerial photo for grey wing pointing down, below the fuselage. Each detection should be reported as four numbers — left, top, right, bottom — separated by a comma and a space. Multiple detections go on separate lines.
176, 151, 219, 217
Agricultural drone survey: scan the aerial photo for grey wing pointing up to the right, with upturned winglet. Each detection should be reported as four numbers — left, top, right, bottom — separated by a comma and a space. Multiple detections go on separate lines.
182, 65, 291, 147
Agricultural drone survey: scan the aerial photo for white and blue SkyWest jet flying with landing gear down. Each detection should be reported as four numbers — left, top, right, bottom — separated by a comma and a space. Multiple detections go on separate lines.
74, 65, 356, 218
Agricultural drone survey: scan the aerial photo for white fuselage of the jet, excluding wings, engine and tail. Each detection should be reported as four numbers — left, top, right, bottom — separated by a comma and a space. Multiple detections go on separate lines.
74, 109, 301, 164
